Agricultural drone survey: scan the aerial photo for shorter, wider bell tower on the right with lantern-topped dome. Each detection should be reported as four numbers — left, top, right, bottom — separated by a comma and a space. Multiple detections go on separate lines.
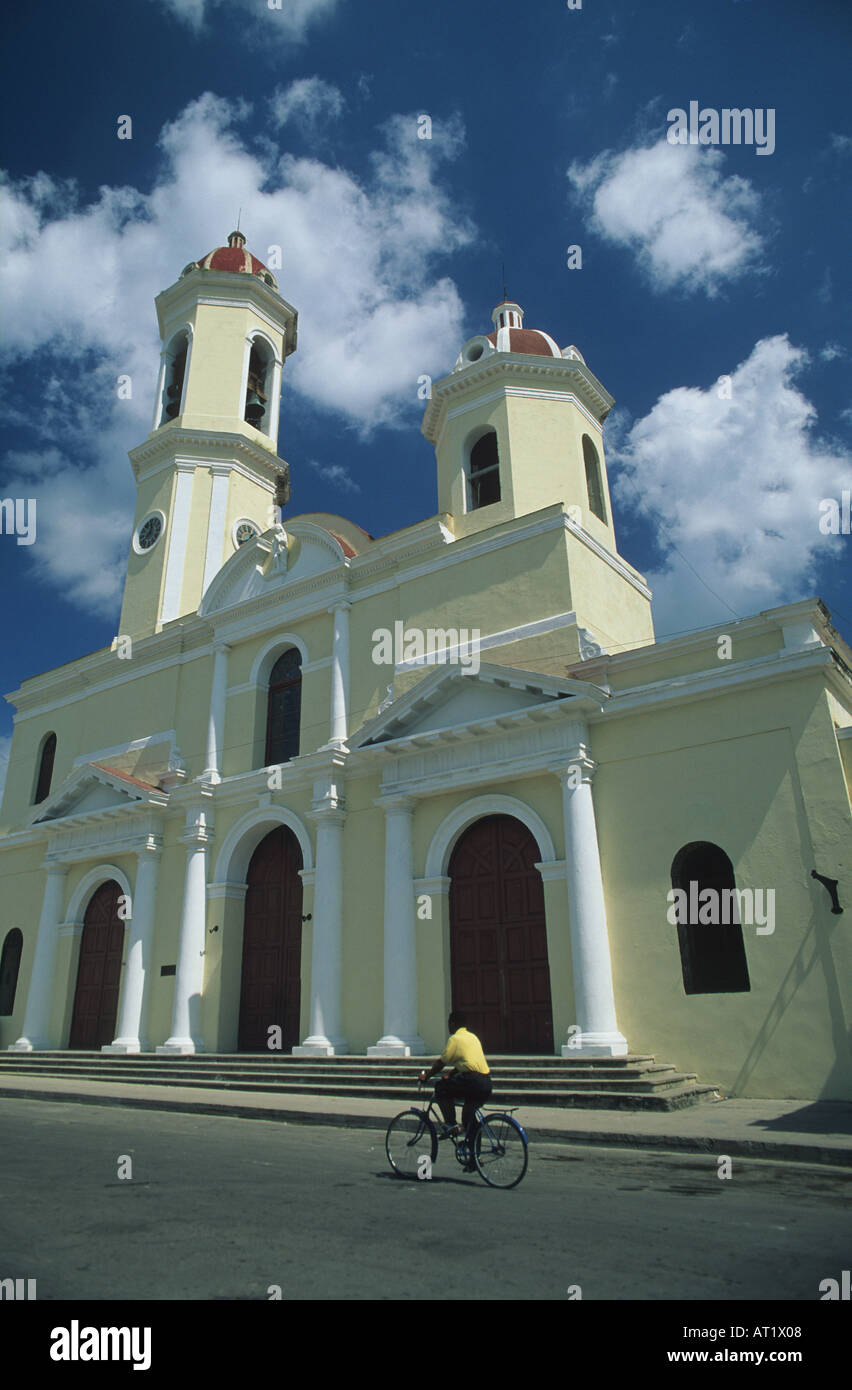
421, 299, 653, 651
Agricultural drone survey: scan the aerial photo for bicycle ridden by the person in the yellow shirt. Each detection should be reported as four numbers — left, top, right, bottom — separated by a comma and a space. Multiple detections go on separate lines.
385, 1083, 530, 1188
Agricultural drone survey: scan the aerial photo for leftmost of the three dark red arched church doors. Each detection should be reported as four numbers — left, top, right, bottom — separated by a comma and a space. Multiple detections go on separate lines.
68, 880, 125, 1051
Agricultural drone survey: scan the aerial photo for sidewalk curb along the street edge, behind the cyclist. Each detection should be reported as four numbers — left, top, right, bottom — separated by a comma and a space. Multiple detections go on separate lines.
0, 1086, 852, 1169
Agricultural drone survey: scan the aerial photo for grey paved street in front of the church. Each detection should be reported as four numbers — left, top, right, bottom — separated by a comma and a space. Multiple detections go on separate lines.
0, 1099, 852, 1301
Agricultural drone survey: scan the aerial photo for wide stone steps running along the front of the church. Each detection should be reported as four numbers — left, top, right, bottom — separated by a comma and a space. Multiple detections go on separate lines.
0, 1052, 720, 1111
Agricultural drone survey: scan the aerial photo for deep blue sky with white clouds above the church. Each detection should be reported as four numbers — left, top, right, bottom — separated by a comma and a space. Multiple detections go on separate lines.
0, 0, 852, 781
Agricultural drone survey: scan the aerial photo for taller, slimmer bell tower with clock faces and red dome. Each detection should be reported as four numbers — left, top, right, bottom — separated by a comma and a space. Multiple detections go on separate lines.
120, 232, 297, 637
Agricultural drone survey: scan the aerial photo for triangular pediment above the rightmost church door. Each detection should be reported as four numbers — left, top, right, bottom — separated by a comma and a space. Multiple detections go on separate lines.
349, 663, 609, 749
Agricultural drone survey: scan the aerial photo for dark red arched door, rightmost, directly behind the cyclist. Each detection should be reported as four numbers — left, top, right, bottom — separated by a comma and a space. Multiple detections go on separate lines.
449, 816, 553, 1055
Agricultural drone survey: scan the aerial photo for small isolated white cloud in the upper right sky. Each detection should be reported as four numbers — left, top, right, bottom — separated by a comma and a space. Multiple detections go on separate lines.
568, 139, 763, 296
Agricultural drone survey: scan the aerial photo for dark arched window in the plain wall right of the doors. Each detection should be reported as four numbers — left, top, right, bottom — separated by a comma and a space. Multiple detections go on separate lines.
671, 840, 751, 994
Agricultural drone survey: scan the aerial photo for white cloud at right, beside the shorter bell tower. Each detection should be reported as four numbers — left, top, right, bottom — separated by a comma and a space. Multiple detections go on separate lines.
607, 335, 852, 632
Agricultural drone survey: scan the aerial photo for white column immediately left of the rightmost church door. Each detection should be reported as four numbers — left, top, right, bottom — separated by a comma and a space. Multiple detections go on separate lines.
367, 796, 425, 1056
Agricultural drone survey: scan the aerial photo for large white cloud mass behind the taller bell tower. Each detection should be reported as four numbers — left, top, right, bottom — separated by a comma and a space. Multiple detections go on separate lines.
0, 93, 473, 616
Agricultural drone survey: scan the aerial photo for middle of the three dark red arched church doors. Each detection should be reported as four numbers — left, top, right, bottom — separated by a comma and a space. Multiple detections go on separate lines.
238, 826, 302, 1052
